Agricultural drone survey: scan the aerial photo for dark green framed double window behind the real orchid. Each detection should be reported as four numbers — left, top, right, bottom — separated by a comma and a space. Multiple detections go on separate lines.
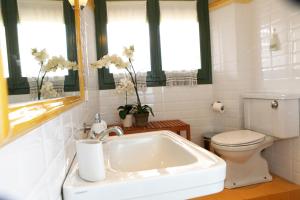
94, 0, 212, 89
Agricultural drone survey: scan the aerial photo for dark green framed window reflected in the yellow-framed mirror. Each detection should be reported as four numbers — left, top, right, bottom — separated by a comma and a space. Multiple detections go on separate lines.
0, 0, 79, 95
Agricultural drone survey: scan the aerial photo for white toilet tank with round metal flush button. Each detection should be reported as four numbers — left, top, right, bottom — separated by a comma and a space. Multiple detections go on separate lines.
243, 93, 300, 139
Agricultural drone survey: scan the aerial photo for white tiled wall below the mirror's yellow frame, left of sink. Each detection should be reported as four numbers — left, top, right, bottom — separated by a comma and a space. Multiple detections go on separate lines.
0, 109, 72, 199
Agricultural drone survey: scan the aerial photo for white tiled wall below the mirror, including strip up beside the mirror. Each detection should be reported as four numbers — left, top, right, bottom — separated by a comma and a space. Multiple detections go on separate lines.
0, 5, 99, 200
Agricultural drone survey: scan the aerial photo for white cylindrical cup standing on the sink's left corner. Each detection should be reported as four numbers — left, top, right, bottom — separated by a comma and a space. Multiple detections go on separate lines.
76, 140, 105, 181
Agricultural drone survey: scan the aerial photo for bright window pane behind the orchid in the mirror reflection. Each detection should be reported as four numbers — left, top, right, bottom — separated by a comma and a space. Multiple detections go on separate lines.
18, 0, 68, 77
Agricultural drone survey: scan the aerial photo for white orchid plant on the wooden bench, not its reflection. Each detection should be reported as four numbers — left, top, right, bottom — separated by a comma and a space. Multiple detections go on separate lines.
91, 46, 154, 116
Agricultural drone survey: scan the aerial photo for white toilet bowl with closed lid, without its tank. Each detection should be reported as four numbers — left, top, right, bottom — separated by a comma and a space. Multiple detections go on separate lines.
211, 130, 273, 188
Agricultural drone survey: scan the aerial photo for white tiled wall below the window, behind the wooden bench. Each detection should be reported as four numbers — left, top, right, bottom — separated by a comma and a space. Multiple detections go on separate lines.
100, 85, 213, 144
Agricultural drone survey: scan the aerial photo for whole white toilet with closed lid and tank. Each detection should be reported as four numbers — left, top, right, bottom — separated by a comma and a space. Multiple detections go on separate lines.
211, 93, 300, 189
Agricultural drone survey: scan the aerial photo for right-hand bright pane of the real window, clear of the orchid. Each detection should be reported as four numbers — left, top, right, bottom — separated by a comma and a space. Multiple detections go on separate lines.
160, 1, 201, 71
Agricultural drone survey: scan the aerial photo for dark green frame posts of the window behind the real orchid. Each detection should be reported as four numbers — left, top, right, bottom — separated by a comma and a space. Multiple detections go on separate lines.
94, 0, 212, 90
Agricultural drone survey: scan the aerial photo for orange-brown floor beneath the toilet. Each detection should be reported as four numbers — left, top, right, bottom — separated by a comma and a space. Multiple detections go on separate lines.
193, 176, 300, 200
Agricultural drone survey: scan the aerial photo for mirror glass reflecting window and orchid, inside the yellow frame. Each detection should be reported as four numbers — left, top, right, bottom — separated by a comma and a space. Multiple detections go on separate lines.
0, 0, 79, 103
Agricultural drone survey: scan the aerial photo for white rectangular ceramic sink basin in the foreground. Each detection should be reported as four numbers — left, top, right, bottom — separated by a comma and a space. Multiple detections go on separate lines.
63, 131, 226, 200
